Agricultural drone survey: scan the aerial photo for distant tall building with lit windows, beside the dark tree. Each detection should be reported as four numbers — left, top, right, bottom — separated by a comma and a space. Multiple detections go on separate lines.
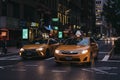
96, 0, 107, 37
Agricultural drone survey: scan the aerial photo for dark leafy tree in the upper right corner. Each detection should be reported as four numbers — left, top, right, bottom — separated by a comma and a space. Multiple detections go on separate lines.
102, 0, 120, 34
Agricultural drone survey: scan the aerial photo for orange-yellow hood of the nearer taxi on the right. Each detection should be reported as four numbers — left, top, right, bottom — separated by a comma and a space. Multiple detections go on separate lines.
57, 45, 90, 50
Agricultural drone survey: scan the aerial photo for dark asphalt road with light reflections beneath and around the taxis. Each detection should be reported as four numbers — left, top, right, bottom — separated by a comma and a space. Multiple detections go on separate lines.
0, 41, 120, 80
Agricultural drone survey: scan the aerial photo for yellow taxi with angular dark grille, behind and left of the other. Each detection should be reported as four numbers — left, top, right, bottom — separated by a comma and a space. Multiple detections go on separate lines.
19, 38, 59, 59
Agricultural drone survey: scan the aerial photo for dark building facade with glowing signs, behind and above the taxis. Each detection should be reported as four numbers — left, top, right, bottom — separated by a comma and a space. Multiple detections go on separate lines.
0, 0, 95, 44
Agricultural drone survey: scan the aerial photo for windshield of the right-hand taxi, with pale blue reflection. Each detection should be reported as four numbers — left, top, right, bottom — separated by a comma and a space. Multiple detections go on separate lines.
64, 38, 89, 46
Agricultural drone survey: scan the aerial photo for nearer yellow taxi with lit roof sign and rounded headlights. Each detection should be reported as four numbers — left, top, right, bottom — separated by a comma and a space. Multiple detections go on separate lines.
54, 37, 99, 64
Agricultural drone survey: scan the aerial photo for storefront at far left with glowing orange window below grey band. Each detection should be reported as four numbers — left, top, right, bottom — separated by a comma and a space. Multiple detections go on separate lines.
0, 16, 21, 46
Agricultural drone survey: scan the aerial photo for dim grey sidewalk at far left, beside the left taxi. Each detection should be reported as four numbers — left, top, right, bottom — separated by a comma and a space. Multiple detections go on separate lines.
0, 47, 19, 57
